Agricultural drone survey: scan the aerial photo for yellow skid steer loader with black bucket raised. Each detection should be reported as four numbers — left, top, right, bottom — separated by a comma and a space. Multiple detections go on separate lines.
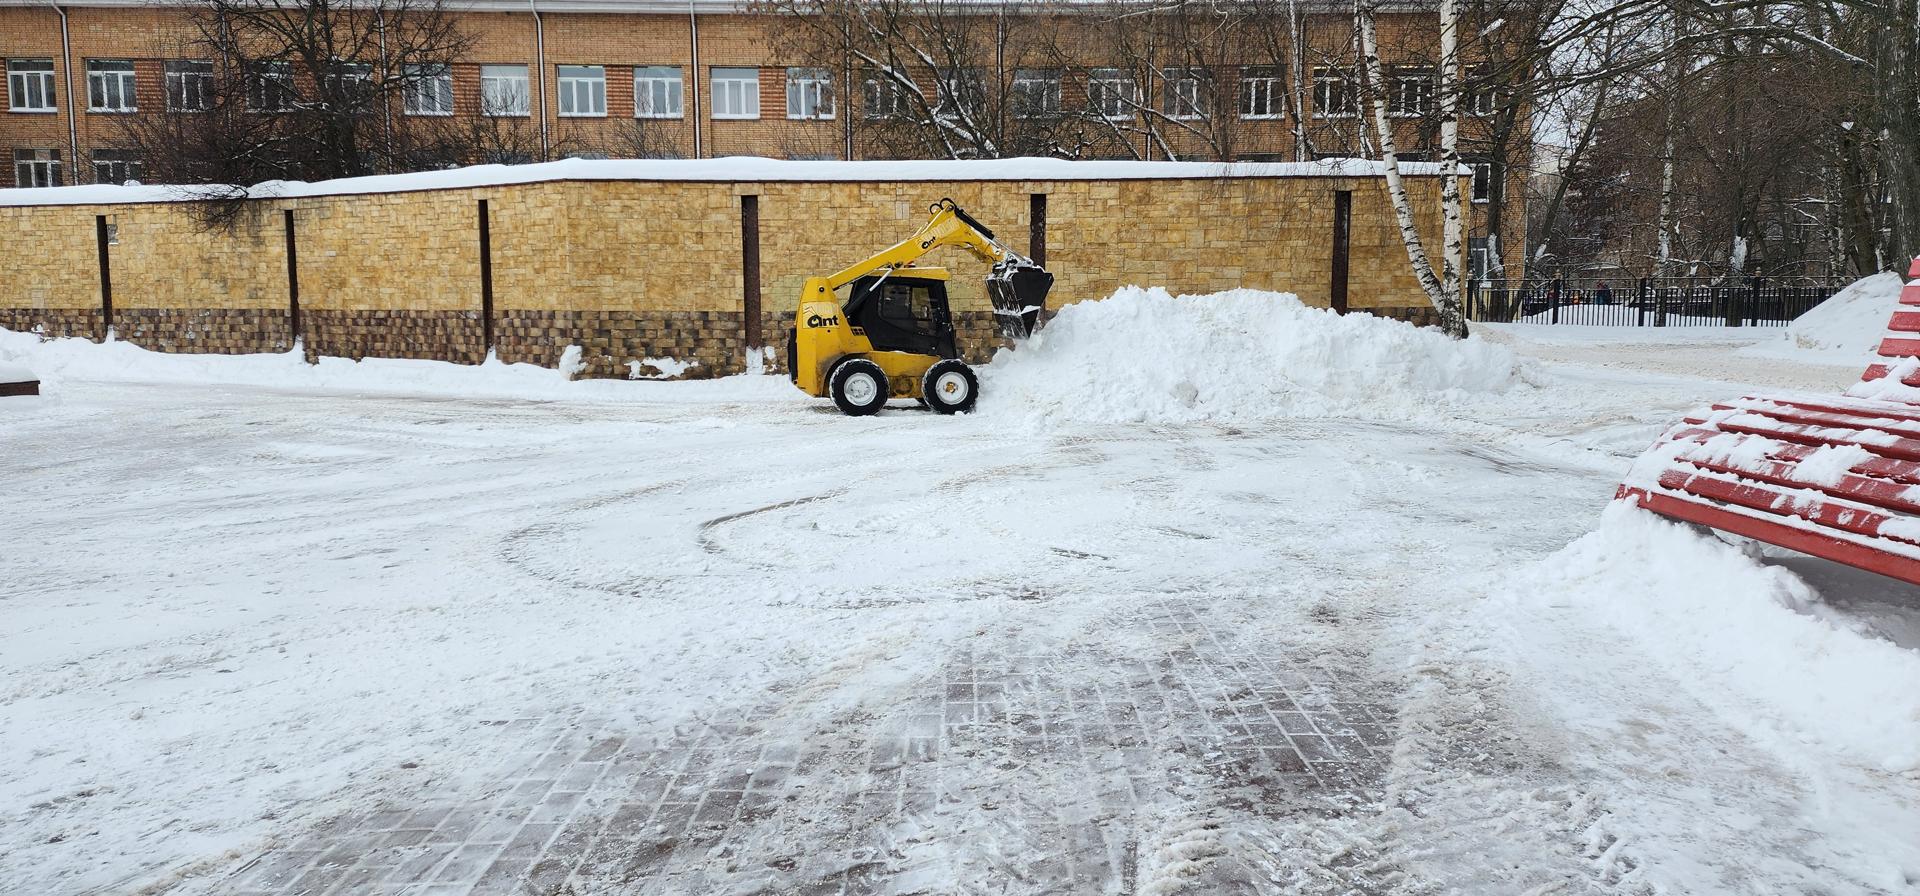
787, 200, 1054, 416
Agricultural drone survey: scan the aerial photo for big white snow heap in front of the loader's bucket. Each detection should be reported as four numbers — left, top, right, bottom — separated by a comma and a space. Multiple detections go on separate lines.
981, 286, 1523, 422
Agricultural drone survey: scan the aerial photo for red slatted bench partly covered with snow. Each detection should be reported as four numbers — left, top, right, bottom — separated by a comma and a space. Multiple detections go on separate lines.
1619, 259, 1920, 585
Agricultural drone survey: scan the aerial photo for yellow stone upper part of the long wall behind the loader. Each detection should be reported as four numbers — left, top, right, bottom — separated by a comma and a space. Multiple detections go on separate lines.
0, 169, 1440, 368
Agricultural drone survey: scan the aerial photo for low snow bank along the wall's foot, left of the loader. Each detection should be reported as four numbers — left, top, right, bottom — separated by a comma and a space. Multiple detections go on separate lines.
0, 328, 797, 401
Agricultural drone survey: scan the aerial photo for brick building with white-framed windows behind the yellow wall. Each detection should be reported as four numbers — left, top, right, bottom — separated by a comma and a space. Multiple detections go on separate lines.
0, 0, 1530, 266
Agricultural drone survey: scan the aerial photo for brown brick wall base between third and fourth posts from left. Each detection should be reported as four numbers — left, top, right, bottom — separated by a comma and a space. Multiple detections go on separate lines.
493, 311, 744, 380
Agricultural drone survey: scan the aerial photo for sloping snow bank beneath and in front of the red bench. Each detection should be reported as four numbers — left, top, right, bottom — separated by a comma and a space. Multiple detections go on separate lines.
1505, 503, 1920, 771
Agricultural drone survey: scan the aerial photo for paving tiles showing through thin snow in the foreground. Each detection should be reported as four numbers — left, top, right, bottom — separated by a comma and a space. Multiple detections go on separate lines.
217, 597, 1394, 896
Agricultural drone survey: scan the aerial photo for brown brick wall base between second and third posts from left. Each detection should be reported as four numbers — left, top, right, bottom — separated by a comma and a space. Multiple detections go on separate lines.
300, 309, 487, 366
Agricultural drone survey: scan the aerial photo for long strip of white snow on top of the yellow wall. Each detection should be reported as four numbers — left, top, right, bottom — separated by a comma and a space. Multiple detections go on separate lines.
0, 155, 1471, 205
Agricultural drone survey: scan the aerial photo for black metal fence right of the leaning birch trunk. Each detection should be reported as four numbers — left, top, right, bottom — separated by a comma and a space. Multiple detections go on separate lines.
1467, 276, 1847, 326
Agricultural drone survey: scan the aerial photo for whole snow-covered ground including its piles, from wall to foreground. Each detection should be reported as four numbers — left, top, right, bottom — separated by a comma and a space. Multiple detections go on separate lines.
0, 290, 1920, 894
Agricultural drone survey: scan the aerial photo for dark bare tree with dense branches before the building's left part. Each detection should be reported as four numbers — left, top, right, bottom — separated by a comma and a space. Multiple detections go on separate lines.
123, 0, 470, 210
